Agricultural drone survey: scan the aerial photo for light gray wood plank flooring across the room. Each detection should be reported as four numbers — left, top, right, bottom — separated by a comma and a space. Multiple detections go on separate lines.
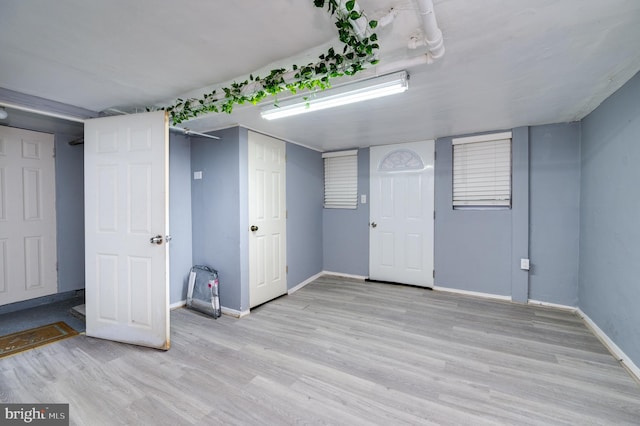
0, 277, 640, 425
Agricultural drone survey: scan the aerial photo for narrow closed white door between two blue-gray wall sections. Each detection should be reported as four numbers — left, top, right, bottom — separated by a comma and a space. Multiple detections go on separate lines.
248, 132, 287, 308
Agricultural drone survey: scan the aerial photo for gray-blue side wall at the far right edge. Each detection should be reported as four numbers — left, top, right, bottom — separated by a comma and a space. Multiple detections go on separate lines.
578, 74, 640, 366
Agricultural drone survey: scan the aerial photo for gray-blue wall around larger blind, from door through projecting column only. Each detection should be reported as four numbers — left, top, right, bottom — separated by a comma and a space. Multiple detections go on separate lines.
434, 128, 529, 302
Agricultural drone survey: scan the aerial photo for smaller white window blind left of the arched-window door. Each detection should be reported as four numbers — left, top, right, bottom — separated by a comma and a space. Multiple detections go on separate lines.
322, 149, 358, 209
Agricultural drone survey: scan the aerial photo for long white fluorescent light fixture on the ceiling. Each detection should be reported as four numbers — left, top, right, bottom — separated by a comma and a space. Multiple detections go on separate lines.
260, 71, 409, 120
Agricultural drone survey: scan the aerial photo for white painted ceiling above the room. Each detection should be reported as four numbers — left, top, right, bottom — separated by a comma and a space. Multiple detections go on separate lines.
0, 0, 640, 150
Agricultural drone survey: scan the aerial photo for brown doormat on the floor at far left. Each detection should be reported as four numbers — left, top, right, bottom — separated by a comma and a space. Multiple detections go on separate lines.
0, 321, 78, 358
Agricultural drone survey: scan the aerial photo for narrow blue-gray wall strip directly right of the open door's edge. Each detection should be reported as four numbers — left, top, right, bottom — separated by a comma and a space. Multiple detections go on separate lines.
169, 132, 193, 303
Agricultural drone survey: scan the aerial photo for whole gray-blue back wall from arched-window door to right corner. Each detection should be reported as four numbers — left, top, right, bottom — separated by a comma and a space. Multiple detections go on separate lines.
435, 123, 580, 306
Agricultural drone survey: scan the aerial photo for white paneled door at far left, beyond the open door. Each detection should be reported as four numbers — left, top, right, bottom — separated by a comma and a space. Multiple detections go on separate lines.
0, 126, 58, 305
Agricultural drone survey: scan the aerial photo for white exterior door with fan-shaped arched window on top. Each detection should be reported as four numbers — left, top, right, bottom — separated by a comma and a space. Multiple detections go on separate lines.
369, 141, 435, 287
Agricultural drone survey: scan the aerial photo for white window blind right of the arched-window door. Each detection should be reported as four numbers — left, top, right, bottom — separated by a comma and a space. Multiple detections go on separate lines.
453, 132, 511, 207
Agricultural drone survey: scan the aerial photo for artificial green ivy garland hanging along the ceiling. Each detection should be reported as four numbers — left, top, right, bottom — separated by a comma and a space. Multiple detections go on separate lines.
162, 0, 380, 124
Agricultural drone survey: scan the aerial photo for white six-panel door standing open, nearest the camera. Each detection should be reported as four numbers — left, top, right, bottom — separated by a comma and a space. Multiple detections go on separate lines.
84, 111, 169, 349
